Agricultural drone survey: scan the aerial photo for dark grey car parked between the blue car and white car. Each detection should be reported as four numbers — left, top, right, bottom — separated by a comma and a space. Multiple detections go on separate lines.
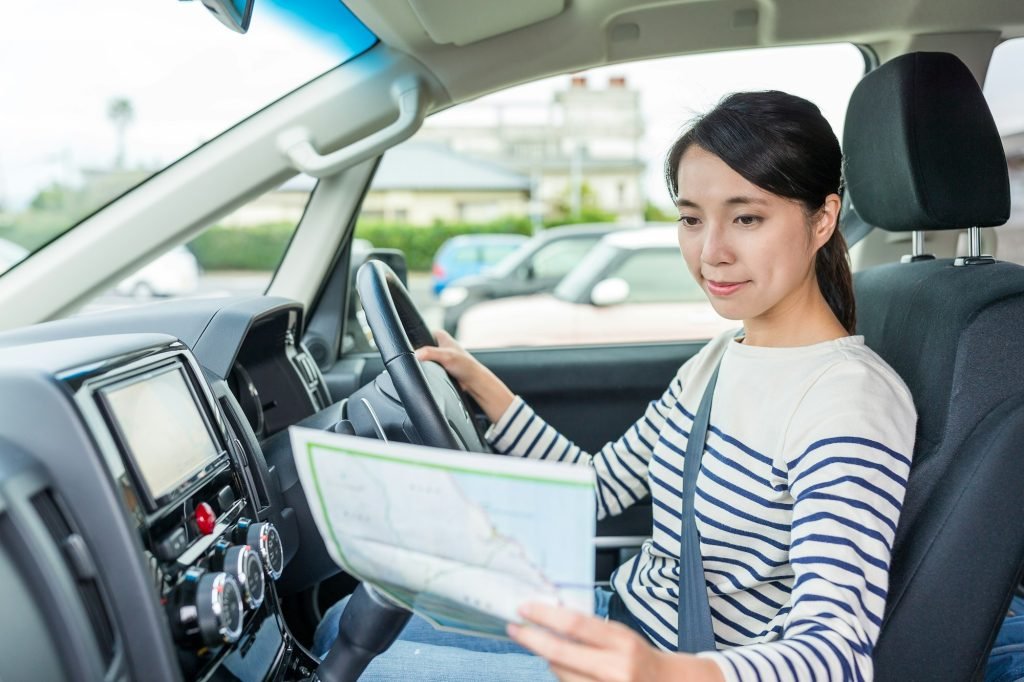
440, 223, 623, 334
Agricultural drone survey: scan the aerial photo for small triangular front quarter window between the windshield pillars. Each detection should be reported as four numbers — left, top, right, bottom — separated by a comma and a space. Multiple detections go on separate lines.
79, 175, 315, 312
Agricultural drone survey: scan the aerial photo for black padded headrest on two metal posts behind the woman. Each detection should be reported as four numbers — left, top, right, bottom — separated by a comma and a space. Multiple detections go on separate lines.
843, 52, 1010, 231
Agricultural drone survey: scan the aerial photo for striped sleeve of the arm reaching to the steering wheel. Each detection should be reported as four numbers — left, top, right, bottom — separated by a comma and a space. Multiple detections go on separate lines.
484, 366, 685, 518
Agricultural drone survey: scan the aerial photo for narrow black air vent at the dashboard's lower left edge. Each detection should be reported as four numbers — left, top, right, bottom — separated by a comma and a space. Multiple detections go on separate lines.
32, 491, 116, 666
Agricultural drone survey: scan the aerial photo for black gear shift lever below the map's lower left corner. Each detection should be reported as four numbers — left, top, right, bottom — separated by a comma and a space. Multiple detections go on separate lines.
312, 583, 412, 682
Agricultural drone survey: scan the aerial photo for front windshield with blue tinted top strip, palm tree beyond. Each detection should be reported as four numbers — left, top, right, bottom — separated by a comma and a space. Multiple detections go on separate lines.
0, 0, 377, 270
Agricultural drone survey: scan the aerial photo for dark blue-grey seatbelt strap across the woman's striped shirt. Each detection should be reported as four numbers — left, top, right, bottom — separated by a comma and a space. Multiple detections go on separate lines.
678, 365, 721, 653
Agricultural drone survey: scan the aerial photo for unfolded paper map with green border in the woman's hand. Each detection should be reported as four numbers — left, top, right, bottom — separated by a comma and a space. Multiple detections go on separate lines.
290, 427, 596, 637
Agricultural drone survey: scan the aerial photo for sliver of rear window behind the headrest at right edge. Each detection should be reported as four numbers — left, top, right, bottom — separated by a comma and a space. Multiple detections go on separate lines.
983, 38, 1024, 264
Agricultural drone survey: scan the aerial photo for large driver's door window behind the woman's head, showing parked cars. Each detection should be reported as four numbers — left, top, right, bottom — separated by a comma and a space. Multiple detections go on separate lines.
350, 44, 865, 347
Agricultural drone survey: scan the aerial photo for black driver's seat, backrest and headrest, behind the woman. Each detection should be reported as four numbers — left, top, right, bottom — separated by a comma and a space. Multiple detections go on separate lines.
844, 53, 1024, 680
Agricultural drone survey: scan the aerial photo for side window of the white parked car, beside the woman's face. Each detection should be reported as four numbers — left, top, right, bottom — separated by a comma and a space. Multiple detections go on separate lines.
609, 249, 707, 303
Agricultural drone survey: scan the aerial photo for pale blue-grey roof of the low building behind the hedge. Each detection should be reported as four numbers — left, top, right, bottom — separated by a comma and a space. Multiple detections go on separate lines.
280, 142, 529, 191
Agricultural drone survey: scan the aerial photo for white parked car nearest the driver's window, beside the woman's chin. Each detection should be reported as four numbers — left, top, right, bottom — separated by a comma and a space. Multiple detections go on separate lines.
458, 226, 739, 348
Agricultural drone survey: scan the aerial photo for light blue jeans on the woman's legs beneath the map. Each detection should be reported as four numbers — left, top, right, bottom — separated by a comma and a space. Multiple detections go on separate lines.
313, 588, 611, 682
